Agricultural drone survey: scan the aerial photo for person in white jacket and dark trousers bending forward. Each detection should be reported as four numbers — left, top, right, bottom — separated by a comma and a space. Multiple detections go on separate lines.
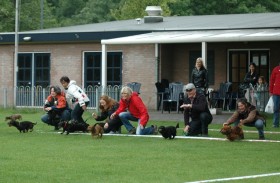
60, 76, 89, 123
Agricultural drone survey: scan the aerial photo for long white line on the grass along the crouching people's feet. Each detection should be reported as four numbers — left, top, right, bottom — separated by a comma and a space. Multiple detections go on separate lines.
37, 131, 280, 143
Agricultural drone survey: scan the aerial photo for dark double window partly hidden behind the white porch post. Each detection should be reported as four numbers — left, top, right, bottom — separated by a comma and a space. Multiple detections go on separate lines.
84, 52, 122, 87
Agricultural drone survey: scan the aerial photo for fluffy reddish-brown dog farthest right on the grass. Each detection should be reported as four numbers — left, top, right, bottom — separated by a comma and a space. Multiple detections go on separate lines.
220, 125, 244, 141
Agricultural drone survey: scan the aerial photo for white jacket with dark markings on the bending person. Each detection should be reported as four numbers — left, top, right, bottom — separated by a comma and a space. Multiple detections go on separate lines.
66, 80, 89, 106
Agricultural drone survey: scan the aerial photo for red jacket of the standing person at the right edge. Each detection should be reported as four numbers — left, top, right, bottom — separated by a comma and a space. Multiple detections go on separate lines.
269, 66, 280, 95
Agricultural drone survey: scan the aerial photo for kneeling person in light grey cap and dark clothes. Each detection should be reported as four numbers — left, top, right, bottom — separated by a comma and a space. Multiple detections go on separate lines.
180, 83, 213, 136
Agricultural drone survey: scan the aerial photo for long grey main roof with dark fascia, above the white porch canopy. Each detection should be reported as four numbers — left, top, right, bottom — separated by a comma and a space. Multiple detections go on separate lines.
0, 13, 280, 44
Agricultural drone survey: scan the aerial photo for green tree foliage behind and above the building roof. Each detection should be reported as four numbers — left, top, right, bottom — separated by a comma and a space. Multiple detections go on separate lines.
0, 0, 280, 32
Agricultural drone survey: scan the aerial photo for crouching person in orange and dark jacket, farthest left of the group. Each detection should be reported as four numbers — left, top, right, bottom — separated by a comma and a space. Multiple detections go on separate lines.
41, 86, 71, 130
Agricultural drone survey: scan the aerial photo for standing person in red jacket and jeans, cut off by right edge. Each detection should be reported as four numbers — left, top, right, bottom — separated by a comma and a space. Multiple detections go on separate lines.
269, 65, 280, 128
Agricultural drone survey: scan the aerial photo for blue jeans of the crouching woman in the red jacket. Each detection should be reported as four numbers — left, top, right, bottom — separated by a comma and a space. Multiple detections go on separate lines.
119, 112, 154, 135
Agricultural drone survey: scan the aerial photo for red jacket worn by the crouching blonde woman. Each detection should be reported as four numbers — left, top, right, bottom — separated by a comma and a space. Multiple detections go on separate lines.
116, 92, 149, 126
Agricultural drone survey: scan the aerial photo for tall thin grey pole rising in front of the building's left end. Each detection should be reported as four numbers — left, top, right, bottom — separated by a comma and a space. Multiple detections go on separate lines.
14, 0, 19, 106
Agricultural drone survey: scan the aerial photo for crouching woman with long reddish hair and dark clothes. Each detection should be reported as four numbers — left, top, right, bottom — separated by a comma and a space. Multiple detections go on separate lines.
92, 95, 123, 133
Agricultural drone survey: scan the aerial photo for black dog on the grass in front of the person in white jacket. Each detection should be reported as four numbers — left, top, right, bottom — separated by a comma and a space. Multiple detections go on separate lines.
58, 121, 89, 135
